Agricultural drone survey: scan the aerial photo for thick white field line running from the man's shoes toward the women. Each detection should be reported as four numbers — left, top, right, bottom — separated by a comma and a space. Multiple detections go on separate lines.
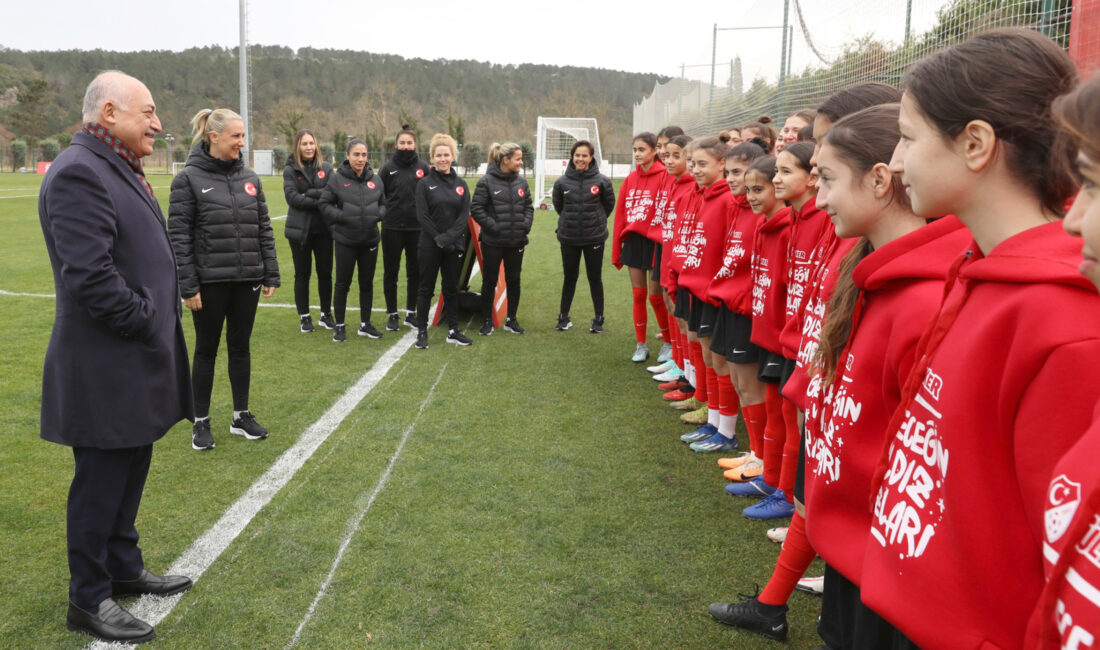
88, 331, 416, 650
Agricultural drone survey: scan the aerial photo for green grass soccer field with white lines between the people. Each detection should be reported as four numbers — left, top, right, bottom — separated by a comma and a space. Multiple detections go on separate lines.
0, 174, 822, 648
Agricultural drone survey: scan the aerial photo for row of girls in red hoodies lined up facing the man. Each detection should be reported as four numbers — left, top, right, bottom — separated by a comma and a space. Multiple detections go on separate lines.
620, 30, 1100, 648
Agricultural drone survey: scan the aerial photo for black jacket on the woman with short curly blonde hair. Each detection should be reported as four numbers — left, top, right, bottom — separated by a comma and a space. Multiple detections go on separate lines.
416, 167, 470, 252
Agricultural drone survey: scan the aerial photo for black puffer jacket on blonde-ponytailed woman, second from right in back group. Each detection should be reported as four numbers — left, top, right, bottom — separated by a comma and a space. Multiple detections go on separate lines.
470, 162, 535, 246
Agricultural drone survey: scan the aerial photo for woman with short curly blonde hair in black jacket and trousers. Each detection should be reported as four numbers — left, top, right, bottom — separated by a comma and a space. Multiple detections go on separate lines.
416, 133, 473, 350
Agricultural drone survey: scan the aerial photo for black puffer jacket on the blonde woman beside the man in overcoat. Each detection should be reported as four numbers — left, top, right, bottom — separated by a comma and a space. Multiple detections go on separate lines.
168, 141, 279, 298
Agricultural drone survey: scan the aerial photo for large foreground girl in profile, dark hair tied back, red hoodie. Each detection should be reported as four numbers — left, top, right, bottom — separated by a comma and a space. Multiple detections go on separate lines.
862, 29, 1100, 648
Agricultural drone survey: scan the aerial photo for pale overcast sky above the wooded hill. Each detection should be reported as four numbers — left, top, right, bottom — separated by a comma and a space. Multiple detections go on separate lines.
0, 0, 946, 86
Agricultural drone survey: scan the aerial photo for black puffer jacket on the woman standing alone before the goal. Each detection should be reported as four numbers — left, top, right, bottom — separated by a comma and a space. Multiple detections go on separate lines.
551, 161, 615, 246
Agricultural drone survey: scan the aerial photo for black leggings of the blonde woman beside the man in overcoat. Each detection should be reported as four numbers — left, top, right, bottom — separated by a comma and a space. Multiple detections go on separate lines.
191, 280, 263, 418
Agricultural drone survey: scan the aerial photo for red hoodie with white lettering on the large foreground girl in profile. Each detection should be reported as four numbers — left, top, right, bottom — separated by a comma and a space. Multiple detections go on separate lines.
862, 222, 1100, 648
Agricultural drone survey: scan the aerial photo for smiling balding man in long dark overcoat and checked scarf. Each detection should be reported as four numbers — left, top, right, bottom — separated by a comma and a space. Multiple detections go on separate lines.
39, 70, 193, 642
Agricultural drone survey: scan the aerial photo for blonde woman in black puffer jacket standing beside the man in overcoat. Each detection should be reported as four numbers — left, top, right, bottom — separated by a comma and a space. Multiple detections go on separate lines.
168, 109, 279, 450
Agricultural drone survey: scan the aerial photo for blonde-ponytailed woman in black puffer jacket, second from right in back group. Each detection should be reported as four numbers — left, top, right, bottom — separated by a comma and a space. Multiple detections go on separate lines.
470, 142, 535, 337
